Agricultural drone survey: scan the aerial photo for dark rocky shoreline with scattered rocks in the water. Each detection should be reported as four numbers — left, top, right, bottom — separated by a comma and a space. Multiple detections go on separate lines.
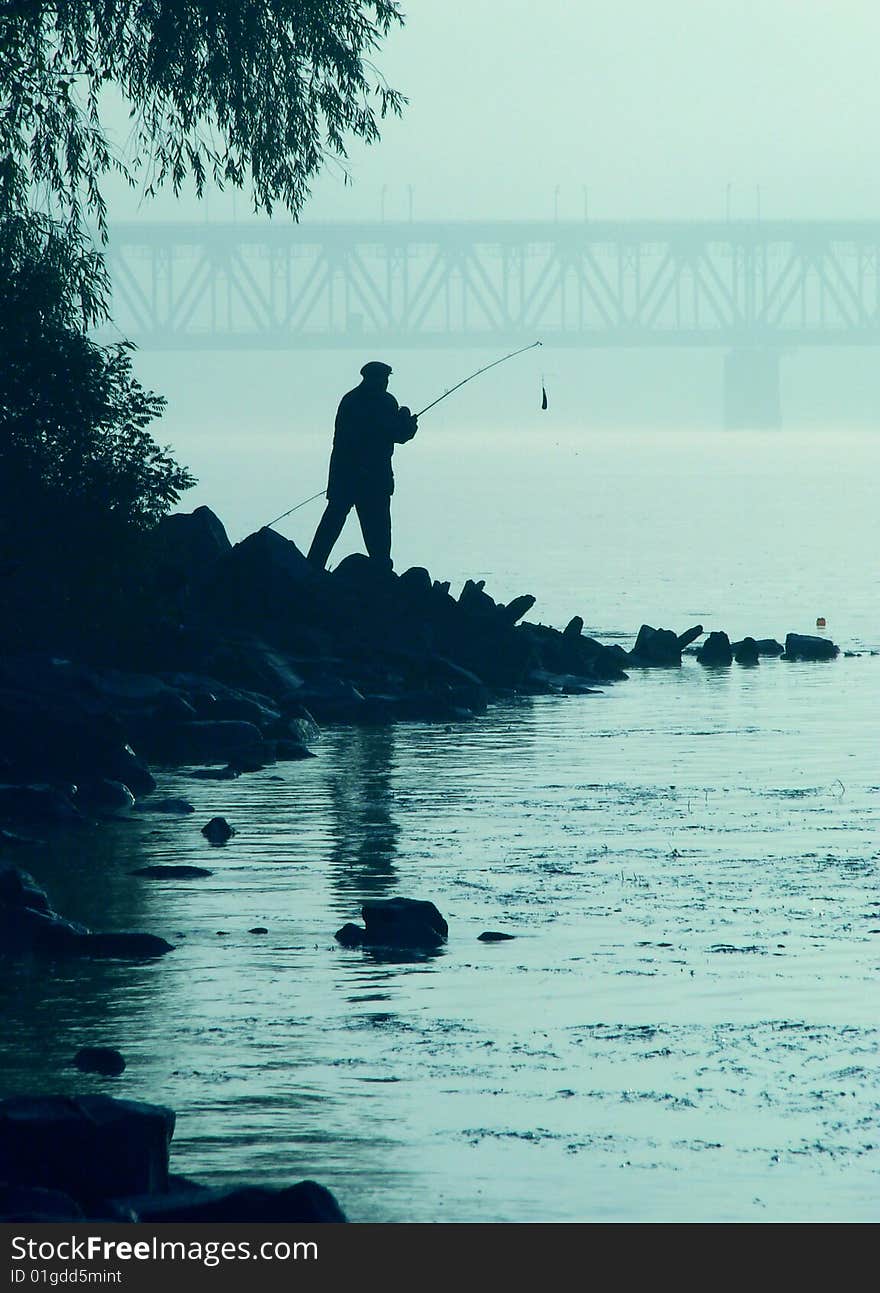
0, 508, 839, 1221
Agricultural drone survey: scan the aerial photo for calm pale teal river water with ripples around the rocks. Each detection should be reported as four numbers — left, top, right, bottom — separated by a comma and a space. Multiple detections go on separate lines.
0, 432, 880, 1222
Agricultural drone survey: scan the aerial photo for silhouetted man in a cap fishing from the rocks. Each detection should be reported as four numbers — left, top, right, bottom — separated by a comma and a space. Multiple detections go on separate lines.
309, 361, 419, 570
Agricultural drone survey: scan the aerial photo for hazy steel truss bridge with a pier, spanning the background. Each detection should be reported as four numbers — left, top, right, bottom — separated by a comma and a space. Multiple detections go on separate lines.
102, 220, 880, 425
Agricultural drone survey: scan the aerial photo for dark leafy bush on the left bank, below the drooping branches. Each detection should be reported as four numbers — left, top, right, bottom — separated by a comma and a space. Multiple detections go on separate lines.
0, 216, 194, 645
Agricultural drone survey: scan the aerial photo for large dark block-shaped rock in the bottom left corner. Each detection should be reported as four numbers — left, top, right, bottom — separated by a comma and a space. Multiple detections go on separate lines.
0, 1095, 174, 1204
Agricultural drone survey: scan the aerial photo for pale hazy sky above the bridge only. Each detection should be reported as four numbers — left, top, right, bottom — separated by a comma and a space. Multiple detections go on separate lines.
106, 0, 880, 220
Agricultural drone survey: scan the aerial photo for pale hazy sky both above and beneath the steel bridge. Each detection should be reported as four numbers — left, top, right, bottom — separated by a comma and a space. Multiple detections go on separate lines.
111, 0, 880, 488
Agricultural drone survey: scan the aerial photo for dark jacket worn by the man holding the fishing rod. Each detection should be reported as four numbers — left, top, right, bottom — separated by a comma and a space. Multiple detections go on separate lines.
327, 383, 416, 502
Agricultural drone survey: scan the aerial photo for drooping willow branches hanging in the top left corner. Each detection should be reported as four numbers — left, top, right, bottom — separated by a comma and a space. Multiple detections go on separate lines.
0, 0, 404, 249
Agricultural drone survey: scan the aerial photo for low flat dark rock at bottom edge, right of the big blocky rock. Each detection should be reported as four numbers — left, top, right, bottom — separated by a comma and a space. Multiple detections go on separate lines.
124, 1181, 348, 1224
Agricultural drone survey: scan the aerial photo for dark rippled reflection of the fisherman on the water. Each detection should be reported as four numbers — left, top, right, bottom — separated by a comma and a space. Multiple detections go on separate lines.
330, 728, 401, 913
